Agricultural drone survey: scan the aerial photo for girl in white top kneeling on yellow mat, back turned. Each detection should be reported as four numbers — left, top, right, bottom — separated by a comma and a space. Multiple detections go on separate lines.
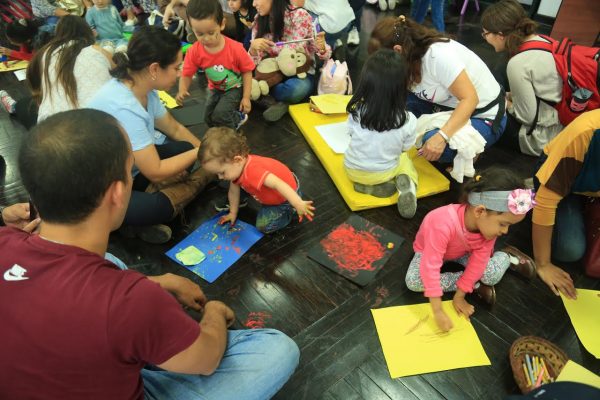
344, 49, 418, 218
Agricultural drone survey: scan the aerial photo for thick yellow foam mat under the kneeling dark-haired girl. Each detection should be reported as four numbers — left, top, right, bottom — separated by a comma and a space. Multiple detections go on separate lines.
290, 103, 450, 211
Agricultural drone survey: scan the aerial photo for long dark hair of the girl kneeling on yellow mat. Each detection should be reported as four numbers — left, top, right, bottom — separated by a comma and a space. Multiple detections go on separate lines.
347, 49, 408, 132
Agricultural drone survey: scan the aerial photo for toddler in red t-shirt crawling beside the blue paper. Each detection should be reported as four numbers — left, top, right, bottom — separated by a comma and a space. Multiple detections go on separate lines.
198, 128, 315, 233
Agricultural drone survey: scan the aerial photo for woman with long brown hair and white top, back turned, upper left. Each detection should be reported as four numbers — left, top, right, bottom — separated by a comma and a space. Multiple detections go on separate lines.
27, 15, 110, 121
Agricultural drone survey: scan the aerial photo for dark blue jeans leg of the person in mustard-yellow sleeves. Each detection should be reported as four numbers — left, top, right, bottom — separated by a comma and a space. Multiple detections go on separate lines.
552, 194, 586, 262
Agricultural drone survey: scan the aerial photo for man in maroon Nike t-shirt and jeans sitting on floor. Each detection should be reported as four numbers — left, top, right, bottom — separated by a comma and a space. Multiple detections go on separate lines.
0, 109, 298, 399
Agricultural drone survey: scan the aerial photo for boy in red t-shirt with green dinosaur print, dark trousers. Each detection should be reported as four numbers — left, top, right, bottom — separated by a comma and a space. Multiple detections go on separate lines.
176, 0, 254, 130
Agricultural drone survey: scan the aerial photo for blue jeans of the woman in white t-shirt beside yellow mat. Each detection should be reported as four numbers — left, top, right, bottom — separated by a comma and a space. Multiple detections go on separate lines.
406, 93, 507, 164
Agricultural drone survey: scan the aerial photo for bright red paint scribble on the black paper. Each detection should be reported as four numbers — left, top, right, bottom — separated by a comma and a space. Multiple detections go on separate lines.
321, 224, 385, 276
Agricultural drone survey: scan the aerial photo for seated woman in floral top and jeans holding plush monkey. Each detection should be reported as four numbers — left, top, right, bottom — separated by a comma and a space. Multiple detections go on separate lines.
248, 0, 331, 121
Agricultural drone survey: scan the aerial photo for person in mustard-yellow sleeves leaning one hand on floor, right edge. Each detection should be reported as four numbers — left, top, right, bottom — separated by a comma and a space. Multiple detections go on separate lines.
532, 109, 600, 298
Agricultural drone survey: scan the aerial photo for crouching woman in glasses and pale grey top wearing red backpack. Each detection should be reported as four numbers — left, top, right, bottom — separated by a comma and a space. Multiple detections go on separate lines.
481, 0, 563, 156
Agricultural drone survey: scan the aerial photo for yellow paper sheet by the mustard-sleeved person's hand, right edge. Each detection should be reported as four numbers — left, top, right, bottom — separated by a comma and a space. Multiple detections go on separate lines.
561, 289, 600, 358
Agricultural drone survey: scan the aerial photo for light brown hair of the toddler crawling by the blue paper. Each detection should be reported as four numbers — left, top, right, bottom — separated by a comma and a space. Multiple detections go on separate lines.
198, 126, 250, 164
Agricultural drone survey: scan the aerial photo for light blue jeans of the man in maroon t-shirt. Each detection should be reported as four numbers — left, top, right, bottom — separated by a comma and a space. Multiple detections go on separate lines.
141, 329, 300, 400
